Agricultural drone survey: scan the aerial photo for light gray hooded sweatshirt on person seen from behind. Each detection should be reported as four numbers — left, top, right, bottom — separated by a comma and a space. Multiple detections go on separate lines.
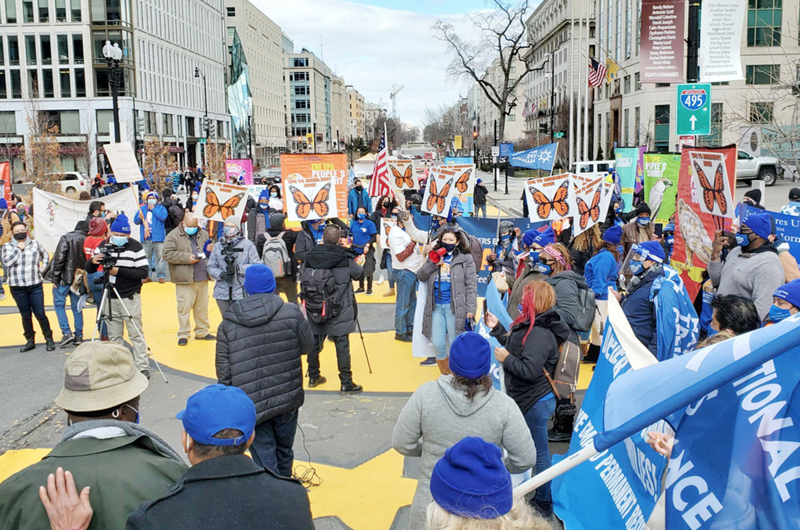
392, 375, 536, 530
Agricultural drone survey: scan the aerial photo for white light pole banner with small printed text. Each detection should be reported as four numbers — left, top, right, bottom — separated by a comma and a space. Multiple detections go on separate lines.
699, 0, 747, 83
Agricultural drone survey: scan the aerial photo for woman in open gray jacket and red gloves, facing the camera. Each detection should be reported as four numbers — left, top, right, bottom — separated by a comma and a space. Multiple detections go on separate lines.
417, 228, 478, 375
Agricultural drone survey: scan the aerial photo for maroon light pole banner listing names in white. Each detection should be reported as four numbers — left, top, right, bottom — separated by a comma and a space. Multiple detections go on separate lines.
640, 0, 684, 83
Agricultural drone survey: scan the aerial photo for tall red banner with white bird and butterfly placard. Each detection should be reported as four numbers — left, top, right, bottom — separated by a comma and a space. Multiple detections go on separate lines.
671, 146, 736, 299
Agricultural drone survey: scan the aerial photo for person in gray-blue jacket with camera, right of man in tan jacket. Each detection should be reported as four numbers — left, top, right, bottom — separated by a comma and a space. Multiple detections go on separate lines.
208, 221, 261, 316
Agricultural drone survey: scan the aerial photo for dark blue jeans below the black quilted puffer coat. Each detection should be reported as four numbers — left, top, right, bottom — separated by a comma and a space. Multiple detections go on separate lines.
250, 410, 298, 477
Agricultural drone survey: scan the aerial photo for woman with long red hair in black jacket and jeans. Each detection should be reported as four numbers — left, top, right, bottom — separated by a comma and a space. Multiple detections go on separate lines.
484, 281, 569, 517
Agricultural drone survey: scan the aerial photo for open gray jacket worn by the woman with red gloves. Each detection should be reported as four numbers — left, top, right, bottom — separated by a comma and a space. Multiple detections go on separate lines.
417, 249, 478, 340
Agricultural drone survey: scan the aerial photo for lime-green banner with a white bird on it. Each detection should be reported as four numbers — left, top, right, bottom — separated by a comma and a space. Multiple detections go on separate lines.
644, 153, 681, 225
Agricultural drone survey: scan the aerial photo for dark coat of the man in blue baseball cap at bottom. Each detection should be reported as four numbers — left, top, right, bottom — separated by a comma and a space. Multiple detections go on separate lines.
125, 455, 314, 530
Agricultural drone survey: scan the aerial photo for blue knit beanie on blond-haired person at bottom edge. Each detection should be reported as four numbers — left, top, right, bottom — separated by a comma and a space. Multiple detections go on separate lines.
430, 436, 514, 519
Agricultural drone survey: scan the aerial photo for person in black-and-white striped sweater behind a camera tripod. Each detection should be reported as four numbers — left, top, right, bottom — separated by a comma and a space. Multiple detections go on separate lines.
86, 214, 150, 379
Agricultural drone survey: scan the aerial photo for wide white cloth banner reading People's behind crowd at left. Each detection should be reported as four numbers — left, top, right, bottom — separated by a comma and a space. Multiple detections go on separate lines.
33, 186, 139, 252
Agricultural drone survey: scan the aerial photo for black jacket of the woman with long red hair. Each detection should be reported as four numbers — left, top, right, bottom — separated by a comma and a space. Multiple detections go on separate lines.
492, 309, 570, 414
